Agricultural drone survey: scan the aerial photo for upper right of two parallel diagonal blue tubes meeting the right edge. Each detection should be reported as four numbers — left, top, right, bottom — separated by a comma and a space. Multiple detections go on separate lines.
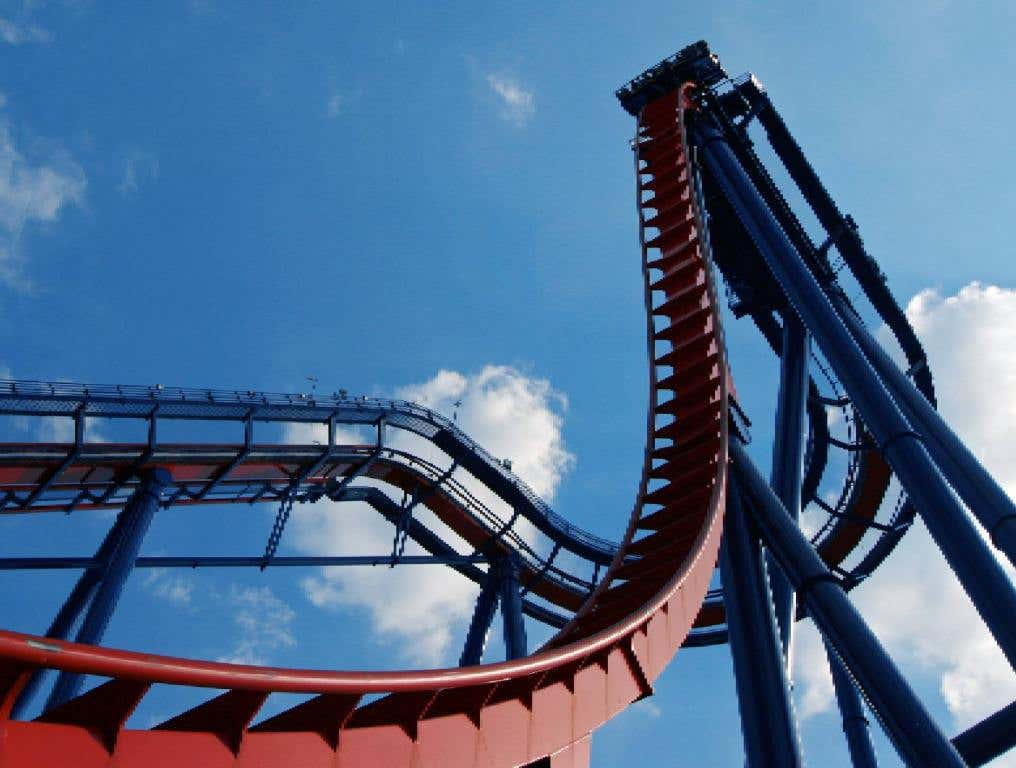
831, 295, 1016, 565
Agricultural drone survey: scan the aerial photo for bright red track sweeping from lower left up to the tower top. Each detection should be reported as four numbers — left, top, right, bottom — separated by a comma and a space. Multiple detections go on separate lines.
0, 85, 727, 768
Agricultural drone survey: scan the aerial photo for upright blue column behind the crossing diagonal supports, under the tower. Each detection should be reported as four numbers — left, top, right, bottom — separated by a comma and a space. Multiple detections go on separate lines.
768, 312, 808, 658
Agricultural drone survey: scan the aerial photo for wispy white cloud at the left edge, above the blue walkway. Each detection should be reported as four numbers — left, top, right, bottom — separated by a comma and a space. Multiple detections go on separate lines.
0, 125, 86, 290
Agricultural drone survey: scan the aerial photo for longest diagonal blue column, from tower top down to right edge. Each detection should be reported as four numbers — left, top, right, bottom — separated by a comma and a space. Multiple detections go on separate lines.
696, 116, 1016, 667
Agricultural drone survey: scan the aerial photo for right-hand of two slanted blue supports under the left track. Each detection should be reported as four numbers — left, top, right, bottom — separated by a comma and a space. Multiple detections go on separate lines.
46, 469, 172, 709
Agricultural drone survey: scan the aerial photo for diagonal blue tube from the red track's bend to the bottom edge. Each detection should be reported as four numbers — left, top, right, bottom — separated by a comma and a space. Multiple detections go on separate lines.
729, 440, 965, 768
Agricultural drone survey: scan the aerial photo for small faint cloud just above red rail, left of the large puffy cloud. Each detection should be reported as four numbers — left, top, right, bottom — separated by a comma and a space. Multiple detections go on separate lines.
217, 584, 297, 665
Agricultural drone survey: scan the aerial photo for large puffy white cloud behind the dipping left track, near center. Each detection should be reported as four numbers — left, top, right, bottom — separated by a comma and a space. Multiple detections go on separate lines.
291, 366, 574, 665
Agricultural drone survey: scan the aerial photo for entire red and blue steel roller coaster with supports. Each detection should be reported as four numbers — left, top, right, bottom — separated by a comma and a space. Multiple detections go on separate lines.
0, 43, 1016, 768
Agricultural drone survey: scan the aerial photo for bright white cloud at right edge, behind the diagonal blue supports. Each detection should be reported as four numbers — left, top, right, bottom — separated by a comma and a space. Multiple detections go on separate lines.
796, 282, 1016, 751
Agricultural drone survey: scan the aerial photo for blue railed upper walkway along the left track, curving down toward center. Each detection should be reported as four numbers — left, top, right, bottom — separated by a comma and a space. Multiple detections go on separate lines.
0, 381, 617, 565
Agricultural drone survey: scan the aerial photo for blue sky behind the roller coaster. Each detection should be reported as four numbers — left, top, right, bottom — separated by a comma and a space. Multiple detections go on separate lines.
0, 0, 1016, 768
